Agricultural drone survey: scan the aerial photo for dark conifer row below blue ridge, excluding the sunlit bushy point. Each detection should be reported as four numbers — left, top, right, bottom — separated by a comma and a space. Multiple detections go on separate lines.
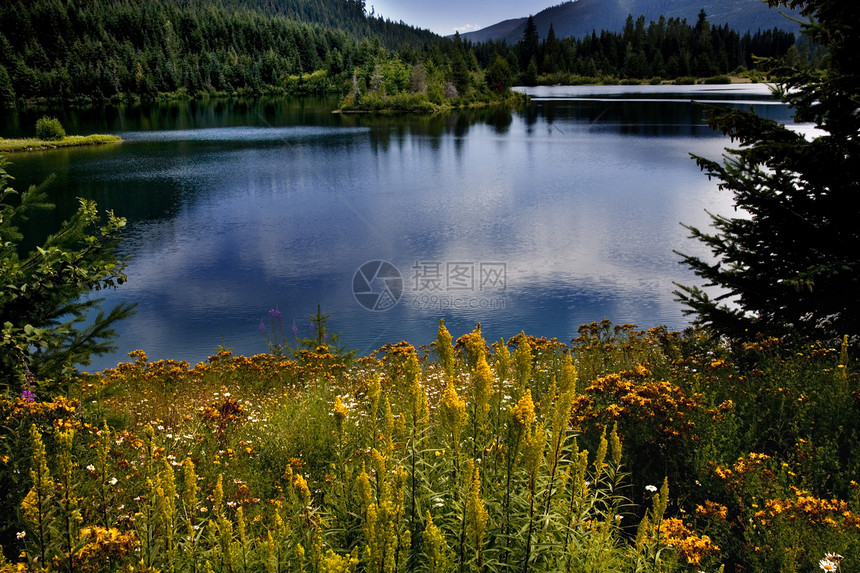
474, 12, 813, 85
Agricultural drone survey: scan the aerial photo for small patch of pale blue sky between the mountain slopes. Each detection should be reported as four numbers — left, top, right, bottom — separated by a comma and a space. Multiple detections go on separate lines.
365, 0, 560, 36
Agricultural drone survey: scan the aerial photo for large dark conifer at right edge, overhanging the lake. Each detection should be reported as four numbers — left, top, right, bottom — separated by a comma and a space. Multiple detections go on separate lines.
676, 0, 860, 339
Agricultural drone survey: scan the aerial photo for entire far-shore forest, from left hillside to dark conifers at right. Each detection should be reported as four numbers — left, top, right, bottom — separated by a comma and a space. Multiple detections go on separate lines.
0, 0, 810, 107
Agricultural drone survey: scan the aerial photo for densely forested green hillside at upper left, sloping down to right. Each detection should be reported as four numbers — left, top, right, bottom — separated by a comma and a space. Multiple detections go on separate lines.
0, 0, 441, 104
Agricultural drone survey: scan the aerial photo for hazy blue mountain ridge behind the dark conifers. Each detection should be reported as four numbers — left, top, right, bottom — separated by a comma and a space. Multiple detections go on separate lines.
461, 0, 800, 44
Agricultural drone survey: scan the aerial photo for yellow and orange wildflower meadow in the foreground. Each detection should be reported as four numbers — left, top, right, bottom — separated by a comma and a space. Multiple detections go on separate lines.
0, 320, 860, 573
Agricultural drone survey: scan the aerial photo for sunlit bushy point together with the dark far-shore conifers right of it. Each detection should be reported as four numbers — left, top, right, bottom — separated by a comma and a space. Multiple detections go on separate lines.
341, 12, 812, 111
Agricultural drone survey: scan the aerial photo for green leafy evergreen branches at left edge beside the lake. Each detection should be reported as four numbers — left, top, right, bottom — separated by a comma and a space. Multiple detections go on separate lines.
0, 157, 132, 392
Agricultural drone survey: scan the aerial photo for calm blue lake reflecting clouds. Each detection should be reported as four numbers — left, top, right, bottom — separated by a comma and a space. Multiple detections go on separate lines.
0, 84, 790, 370
